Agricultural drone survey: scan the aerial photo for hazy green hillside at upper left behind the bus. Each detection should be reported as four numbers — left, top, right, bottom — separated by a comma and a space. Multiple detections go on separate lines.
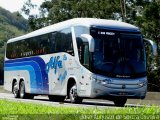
0, 7, 28, 69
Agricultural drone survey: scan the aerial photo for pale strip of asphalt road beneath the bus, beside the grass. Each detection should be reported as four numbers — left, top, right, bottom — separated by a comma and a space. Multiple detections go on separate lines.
0, 93, 142, 108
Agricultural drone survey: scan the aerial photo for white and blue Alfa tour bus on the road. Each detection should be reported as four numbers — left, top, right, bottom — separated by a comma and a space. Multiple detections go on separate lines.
4, 18, 156, 106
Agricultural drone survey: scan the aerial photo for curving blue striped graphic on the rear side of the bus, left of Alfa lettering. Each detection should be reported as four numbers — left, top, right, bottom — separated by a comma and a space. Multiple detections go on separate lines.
4, 57, 49, 94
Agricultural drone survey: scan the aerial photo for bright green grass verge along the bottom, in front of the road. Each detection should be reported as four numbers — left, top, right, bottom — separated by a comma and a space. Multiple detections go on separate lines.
0, 100, 160, 120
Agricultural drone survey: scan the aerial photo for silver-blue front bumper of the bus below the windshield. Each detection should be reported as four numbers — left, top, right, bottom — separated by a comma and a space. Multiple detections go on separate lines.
90, 78, 147, 99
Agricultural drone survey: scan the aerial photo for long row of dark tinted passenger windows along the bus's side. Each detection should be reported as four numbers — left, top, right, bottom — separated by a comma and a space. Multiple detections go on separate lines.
6, 28, 74, 59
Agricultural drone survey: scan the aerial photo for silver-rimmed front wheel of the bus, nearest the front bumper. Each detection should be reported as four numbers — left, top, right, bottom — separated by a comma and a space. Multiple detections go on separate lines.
69, 84, 83, 103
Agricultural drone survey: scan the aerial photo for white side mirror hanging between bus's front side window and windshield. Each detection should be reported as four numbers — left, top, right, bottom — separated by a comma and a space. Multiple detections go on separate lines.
81, 34, 95, 52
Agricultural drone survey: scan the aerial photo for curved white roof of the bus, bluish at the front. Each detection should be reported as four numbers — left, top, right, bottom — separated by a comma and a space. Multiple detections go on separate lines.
7, 18, 139, 43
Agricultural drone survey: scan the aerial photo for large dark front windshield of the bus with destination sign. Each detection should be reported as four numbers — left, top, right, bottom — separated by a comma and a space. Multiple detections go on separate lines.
91, 29, 146, 78
